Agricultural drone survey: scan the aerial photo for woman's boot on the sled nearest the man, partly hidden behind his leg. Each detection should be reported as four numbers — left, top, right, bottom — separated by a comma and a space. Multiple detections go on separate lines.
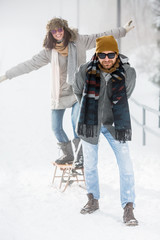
73, 138, 83, 169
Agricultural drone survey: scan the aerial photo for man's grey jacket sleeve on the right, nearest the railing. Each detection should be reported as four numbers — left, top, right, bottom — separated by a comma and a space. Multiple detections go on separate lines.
126, 67, 136, 98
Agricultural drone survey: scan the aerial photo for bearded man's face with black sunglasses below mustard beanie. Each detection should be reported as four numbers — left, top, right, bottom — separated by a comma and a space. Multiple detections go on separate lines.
98, 51, 118, 69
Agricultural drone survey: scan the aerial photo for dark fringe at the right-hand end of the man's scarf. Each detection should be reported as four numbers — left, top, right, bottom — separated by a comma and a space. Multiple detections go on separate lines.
115, 129, 132, 143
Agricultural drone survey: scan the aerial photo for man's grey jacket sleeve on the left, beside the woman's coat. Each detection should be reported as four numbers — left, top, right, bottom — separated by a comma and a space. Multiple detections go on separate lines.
73, 64, 87, 103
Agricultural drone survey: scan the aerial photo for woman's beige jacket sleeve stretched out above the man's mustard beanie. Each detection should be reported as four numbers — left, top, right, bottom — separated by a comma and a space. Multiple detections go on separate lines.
79, 27, 126, 50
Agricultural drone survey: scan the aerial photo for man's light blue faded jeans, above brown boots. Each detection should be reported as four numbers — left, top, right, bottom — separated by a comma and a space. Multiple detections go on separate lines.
82, 127, 135, 208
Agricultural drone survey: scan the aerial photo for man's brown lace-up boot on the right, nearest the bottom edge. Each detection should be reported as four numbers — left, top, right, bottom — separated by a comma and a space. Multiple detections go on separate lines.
123, 203, 138, 226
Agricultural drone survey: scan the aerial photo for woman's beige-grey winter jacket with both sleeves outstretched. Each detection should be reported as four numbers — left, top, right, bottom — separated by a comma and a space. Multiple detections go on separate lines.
5, 27, 126, 109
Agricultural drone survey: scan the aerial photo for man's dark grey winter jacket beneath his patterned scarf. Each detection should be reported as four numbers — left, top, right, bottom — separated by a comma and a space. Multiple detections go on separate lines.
73, 55, 136, 144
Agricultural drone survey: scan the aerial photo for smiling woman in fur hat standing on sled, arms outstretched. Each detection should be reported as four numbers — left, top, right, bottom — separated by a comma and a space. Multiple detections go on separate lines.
0, 18, 133, 167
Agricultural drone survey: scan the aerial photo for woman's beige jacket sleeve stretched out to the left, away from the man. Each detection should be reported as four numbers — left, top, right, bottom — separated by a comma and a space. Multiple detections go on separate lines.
5, 49, 51, 79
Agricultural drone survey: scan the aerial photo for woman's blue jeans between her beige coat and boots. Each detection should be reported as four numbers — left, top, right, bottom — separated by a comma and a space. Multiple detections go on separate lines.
52, 102, 79, 142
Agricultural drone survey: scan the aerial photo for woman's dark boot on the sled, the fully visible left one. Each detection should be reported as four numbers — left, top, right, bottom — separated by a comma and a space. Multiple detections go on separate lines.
55, 141, 74, 164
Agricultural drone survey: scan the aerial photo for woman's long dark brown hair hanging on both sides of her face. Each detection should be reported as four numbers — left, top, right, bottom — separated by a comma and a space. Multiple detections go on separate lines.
43, 28, 71, 49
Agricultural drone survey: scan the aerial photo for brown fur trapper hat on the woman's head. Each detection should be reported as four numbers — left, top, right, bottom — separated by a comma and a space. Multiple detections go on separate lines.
46, 18, 78, 42
